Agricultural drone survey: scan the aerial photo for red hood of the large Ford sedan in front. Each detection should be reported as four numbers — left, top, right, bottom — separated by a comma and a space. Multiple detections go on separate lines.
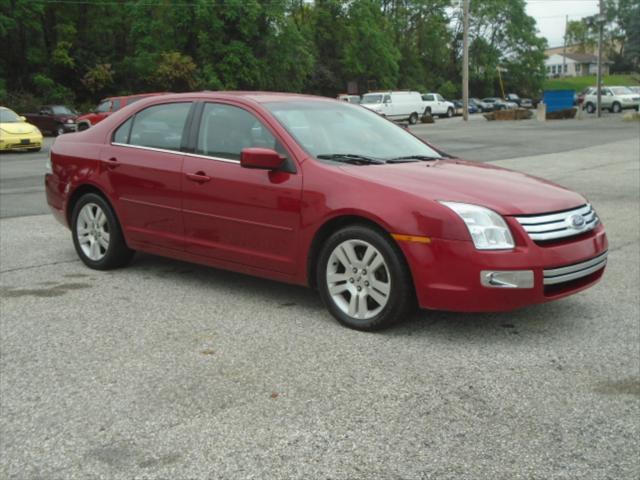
341, 160, 586, 215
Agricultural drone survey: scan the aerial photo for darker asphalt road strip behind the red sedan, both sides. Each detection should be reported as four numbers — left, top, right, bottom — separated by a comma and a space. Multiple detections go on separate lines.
0, 114, 638, 218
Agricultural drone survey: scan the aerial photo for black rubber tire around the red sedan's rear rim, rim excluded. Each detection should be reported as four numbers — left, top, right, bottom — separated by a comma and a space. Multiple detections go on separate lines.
71, 193, 128, 270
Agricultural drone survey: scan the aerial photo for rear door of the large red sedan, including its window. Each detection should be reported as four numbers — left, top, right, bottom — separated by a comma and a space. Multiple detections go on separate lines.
101, 101, 193, 250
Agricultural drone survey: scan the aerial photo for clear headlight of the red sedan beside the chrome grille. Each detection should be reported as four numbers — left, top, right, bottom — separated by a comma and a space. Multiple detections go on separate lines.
440, 202, 515, 250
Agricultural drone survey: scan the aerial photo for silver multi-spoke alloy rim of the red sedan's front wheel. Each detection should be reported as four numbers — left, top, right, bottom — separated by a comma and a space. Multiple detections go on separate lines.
326, 239, 391, 319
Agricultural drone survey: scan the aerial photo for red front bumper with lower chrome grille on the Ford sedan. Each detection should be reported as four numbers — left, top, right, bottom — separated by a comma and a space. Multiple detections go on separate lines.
399, 225, 608, 312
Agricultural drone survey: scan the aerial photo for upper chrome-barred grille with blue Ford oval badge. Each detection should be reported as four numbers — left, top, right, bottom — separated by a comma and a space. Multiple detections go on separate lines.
515, 204, 600, 242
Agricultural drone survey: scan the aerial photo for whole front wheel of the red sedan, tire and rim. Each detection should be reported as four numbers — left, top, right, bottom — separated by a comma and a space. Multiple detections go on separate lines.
316, 225, 415, 331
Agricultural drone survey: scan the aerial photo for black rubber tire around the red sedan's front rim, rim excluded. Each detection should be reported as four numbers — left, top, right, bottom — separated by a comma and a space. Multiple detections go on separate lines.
316, 225, 414, 331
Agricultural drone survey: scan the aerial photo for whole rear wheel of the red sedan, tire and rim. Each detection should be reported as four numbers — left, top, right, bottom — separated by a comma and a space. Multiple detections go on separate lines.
71, 193, 134, 270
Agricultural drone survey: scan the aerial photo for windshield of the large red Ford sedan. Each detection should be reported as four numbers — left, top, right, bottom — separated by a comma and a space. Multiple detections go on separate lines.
265, 101, 441, 160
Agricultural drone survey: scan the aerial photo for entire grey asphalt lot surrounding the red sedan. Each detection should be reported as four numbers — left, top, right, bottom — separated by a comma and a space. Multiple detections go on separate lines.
0, 117, 640, 480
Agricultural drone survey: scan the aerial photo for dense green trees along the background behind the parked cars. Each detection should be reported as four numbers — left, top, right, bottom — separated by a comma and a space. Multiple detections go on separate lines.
0, 0, 545, 108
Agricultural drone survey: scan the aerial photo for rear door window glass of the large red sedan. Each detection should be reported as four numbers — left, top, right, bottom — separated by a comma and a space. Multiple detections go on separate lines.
127, 102, 191, 151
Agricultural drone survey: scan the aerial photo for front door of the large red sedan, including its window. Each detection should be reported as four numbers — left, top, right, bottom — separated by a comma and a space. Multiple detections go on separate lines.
182, 102, 302, 274
